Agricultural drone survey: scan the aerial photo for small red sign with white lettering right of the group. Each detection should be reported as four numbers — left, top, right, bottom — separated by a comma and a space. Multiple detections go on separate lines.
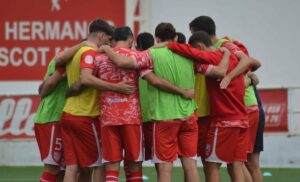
259, 89, 288, 132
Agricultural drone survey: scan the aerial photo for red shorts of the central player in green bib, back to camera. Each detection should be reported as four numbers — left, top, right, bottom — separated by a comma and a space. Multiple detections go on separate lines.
153, 114, 198, 163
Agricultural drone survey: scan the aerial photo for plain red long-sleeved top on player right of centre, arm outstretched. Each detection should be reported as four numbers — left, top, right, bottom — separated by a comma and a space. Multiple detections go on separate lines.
168, 43, 248, 127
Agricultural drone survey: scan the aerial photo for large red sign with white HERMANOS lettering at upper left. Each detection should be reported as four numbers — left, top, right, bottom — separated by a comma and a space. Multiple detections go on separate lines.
0, 0, 125, 81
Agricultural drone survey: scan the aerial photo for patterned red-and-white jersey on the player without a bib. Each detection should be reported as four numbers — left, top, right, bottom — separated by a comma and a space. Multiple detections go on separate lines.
81, 48, 150, 126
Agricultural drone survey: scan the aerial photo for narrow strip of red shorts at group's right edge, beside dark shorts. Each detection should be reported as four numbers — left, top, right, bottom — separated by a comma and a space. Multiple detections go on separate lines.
247, 106, 259, 153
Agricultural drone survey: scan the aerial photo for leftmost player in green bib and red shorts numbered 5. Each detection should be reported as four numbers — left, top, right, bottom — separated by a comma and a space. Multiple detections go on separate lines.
34, 57, 68, 182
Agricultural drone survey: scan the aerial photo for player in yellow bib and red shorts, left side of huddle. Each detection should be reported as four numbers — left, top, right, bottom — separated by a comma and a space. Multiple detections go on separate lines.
57, 19, 135, 182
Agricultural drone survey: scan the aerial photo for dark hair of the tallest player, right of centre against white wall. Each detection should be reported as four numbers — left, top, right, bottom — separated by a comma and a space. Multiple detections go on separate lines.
190, 16, 216, 36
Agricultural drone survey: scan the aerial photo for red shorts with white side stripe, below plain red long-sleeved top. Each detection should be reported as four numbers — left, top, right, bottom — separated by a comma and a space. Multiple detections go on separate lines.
205, 122, 248, 164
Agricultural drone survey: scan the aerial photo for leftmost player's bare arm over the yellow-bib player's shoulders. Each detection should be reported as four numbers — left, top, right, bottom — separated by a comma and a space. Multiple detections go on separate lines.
56, 41, 96, 66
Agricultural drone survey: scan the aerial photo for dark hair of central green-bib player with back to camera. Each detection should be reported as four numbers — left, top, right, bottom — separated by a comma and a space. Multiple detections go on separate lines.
155, 23, 176, 42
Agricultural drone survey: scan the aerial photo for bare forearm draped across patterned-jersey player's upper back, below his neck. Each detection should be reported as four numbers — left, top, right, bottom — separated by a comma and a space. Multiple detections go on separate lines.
97, 45, 137, 69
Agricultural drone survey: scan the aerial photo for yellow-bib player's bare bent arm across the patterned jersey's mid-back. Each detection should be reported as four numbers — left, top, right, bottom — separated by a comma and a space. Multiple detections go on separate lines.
80, 68, 136, 94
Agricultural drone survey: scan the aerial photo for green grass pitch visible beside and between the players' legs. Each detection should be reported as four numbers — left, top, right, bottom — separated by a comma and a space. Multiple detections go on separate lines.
0, 166, 300, 182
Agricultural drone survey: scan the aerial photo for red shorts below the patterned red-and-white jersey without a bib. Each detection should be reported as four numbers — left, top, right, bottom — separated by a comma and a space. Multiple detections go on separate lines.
101, 125, 144, 163
